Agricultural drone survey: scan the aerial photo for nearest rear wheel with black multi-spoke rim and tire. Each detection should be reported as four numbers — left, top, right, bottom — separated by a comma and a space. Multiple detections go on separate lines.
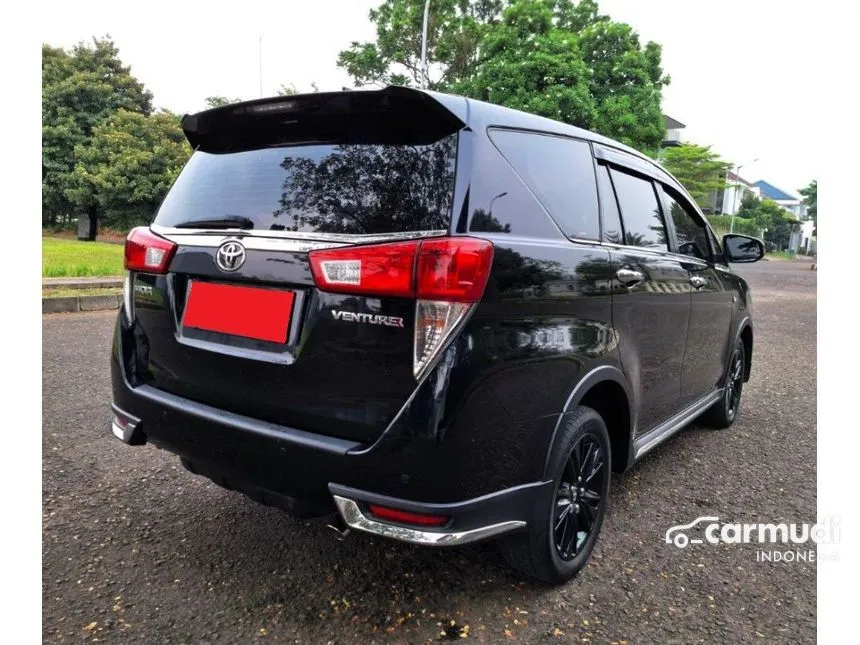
501, 406, 612, 584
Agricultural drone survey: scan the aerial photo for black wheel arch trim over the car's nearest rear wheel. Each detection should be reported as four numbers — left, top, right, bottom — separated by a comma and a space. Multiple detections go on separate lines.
543, 365, 635, 476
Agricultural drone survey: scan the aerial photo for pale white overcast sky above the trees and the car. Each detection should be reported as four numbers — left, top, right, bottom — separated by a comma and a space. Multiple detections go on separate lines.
39, 0, 838, 193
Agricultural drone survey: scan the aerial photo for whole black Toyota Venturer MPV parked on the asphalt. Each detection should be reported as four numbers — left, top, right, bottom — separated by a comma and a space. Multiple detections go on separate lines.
111, 87, 764, 583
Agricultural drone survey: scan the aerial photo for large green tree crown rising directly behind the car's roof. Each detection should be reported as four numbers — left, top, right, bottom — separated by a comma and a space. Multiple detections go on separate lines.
338, 0, 669, 155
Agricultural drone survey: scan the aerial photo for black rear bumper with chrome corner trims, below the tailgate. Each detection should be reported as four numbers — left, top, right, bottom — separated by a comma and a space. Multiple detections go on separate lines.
111, 316, 552, 546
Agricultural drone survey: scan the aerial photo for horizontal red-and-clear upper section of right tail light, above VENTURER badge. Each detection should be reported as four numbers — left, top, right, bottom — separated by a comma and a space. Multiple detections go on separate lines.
309, 237, 493, 302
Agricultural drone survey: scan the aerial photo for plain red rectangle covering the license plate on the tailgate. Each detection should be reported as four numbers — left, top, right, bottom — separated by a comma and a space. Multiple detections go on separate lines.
182, 281, 295, 343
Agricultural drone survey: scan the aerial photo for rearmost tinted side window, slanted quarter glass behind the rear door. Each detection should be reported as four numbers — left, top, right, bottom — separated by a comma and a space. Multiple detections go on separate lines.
490, 129, 600, 240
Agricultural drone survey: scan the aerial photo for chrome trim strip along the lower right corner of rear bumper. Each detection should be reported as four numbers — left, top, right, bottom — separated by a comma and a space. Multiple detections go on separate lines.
333, 495, 526, 546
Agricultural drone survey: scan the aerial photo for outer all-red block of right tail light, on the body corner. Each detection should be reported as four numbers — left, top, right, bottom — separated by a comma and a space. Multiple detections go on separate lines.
417, 237, 493, 302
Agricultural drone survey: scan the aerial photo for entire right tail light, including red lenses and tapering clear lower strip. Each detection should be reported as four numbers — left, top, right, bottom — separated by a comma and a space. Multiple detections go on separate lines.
309, 237, 493, 378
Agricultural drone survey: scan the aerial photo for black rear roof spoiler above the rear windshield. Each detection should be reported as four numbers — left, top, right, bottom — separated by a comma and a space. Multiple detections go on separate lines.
177, 86, 468, 153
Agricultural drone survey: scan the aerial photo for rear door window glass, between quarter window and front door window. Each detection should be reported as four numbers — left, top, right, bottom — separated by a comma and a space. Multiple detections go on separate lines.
610, 168, 669, 251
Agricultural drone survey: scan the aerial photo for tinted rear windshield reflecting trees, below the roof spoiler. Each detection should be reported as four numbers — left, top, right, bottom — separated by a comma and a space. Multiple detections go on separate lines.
155, 134, 457, 234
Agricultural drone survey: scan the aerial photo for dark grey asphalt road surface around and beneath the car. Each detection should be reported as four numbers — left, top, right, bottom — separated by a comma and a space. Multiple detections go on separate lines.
42, 262, 816, 644
